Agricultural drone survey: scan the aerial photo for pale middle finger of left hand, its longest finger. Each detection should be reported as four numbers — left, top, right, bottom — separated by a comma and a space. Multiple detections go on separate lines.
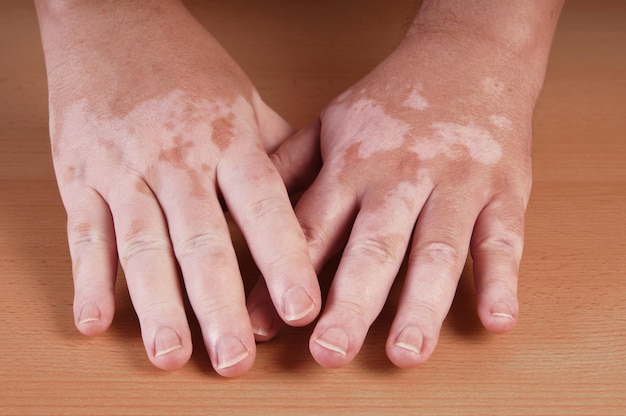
158, 169, 256, 377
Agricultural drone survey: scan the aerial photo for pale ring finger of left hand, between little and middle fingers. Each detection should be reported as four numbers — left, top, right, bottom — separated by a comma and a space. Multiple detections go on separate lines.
107, 178, 192, 370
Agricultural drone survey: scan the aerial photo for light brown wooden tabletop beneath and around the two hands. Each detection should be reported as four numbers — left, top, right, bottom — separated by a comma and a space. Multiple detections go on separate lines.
0, 0, 626, 415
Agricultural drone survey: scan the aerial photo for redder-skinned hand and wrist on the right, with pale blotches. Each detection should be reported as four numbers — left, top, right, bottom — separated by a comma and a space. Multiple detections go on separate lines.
248, 0, 562, 367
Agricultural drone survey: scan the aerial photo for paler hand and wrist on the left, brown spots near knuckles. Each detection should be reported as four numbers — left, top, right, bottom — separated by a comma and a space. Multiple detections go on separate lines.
37, 1, 321, 376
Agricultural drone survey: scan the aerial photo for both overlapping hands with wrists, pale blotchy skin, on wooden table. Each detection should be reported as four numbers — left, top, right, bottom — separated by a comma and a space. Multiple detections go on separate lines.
36, 0, 562, 376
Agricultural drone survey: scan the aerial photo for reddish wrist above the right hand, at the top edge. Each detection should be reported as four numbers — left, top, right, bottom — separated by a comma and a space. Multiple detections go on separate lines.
402, 0, 563, 94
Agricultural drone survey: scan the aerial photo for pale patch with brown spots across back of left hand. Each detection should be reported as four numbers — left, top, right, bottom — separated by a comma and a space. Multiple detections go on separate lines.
51, 90, 253, 198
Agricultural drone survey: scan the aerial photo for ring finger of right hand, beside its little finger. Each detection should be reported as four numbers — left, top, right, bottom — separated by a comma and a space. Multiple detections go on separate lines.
386, 188, 479, 367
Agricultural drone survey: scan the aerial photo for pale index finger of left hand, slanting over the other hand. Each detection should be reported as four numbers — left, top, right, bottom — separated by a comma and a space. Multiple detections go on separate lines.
217, 149, 321, 326
